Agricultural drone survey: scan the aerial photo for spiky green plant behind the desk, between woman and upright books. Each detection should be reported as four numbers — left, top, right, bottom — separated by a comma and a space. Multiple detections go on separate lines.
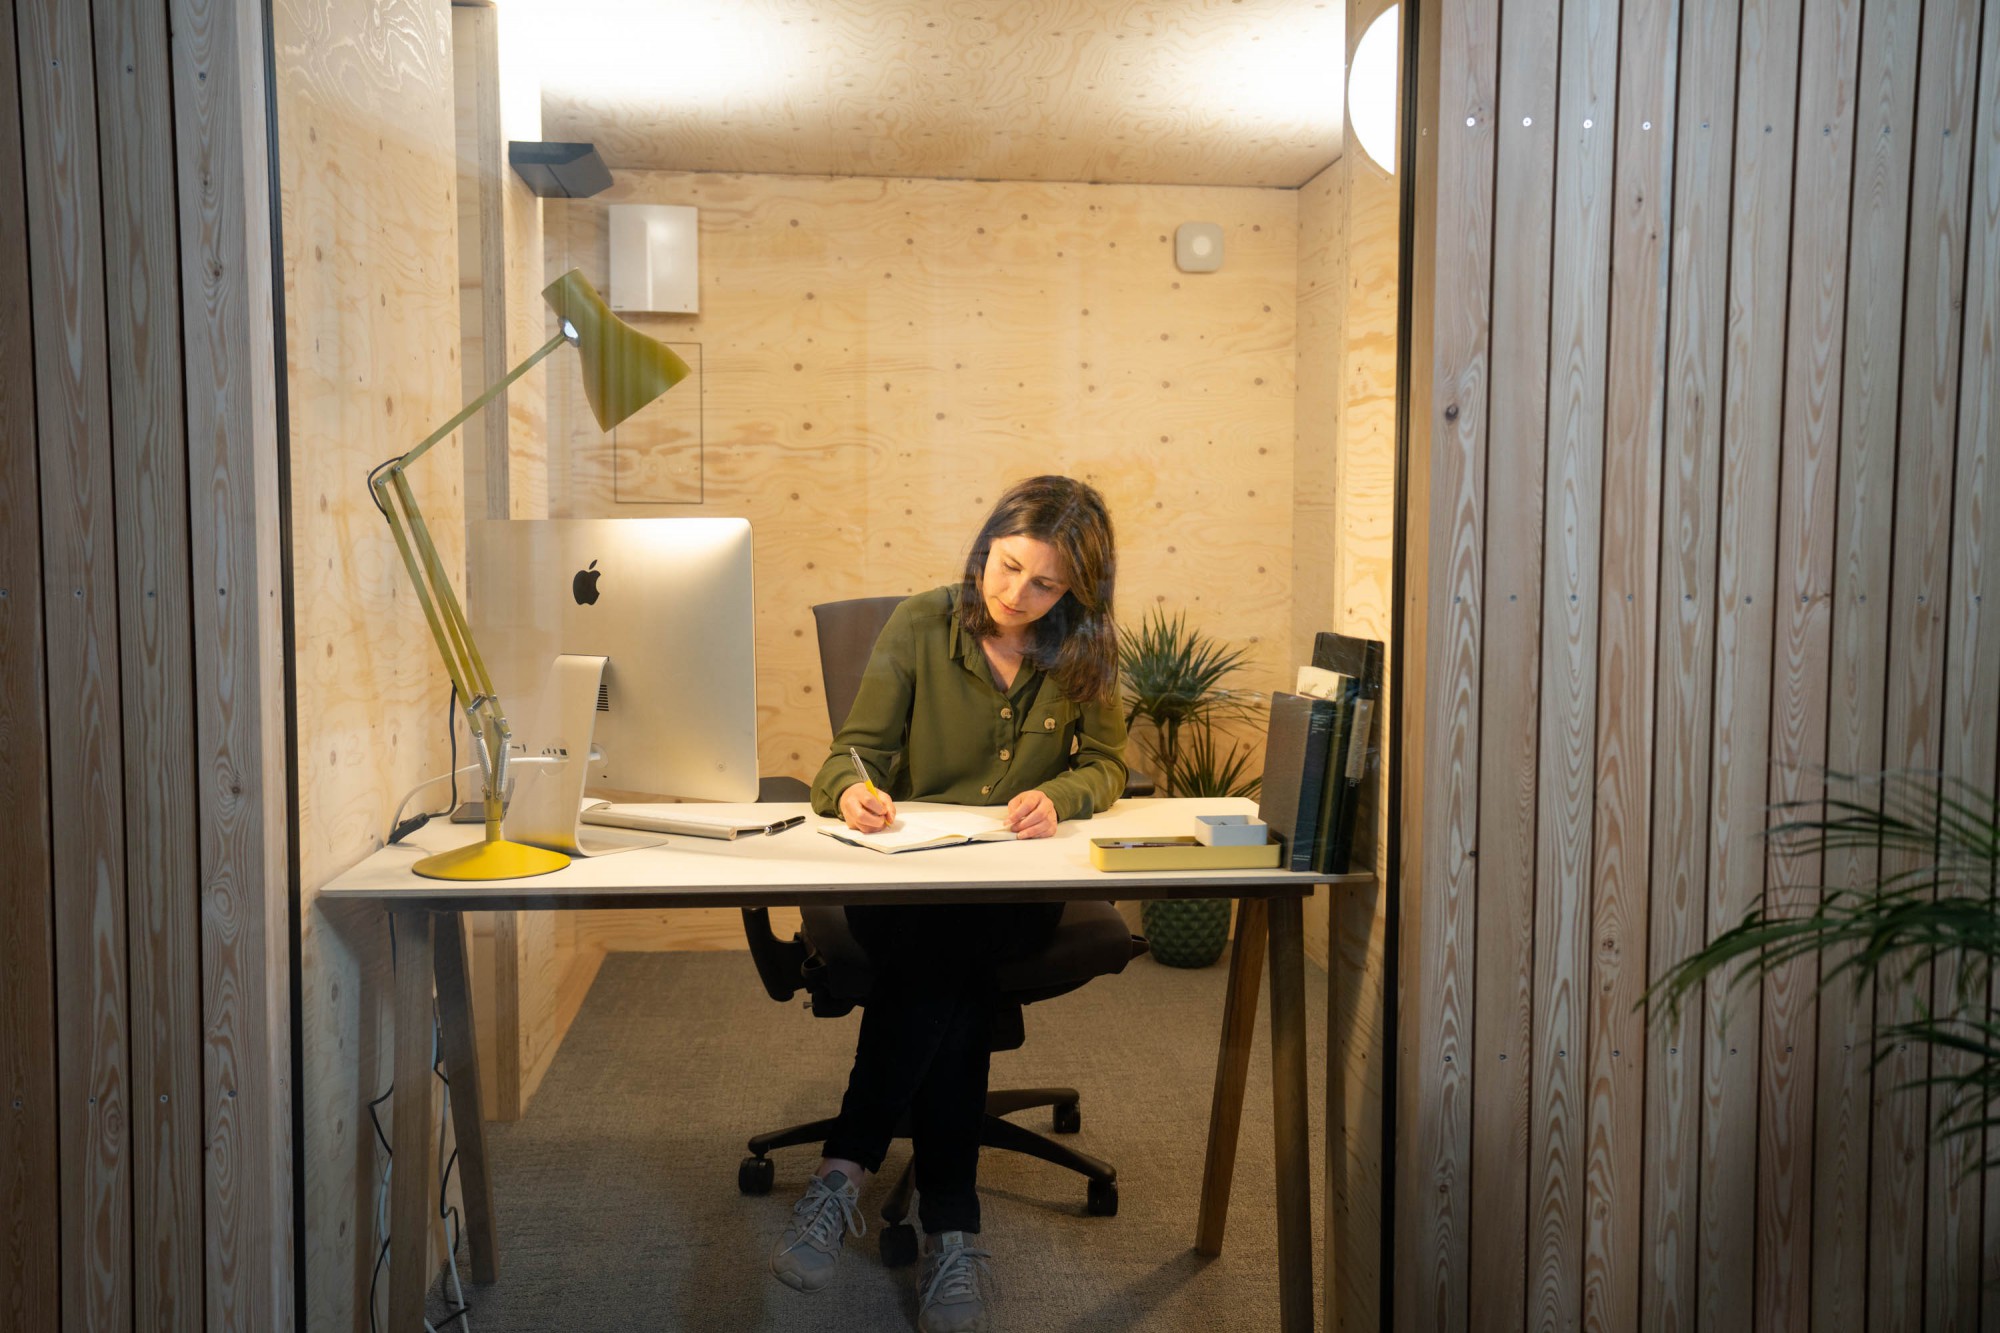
1118, 608, 1248, 797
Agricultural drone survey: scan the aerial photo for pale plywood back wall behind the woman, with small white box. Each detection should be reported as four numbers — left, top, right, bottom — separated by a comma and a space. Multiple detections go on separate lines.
546, 172, 1298, 777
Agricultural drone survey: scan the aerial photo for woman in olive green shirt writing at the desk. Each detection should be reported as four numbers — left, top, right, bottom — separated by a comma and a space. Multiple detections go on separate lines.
770, 476, 1126, 1333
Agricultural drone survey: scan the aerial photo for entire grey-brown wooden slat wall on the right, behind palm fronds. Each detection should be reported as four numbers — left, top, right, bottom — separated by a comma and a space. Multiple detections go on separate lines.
1396, 0, 2000, 1331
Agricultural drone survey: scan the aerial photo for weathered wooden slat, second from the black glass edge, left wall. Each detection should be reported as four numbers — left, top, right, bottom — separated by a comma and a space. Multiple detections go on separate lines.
94, 0, 202, 1327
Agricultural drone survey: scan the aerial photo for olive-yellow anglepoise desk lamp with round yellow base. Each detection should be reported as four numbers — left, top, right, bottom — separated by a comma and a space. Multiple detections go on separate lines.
368, 268, 688, 879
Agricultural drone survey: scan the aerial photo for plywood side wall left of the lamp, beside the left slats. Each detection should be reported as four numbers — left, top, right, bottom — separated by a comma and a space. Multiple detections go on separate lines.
274, 0, 464, 1329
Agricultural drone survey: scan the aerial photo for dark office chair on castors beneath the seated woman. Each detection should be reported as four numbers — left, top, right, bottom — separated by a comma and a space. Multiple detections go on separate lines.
736, 596, 1152, 1267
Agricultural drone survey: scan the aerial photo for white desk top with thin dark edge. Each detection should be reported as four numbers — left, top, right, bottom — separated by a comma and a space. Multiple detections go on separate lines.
320, 797, 1374, 909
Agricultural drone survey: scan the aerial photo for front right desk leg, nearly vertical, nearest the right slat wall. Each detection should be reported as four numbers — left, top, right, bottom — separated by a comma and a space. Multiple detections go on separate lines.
1272, 899, 1312, 1333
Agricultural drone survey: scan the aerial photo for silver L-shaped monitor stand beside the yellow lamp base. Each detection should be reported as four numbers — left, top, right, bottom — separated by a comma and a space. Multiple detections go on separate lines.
506, 652, 666, 857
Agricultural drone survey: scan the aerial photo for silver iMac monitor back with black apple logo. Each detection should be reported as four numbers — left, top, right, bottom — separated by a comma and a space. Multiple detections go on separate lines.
466, 518, 758, 801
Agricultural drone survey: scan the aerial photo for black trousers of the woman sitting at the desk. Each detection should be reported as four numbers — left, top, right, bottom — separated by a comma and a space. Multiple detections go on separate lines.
826, 903, 1062, 1235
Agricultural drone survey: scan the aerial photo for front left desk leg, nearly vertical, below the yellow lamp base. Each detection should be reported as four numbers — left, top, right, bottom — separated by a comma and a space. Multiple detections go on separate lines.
388, 907, 438, 1333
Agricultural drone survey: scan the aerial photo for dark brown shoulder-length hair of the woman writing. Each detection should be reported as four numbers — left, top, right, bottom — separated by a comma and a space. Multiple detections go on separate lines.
958, 476, 1118, 703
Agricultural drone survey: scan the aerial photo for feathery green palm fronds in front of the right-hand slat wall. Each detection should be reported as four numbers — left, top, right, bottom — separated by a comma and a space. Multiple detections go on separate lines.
1642, 771, 2000, 1171
